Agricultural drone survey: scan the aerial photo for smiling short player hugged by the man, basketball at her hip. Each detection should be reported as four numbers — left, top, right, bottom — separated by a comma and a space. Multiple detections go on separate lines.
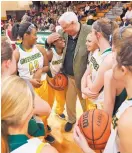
48, 32, 66, 119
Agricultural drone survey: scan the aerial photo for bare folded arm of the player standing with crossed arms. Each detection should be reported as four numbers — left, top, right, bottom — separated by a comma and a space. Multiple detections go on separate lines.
82, 54, 112, 98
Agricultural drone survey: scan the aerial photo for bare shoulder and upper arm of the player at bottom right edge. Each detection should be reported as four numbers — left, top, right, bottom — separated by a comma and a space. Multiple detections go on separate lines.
117, 107, 132, 153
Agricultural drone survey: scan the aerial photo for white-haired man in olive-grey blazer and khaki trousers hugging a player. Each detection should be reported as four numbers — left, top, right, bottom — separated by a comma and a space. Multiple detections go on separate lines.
46, 12, 91, 132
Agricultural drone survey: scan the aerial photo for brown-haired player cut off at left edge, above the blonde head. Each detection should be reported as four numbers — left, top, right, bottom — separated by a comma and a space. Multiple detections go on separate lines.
1, 37, 51, 116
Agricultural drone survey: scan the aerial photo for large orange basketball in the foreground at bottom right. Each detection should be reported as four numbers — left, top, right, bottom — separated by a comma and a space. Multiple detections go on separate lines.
78, 109, 112, 150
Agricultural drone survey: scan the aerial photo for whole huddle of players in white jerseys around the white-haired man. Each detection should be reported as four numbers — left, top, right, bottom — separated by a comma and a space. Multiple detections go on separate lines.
1, 12, 132, 153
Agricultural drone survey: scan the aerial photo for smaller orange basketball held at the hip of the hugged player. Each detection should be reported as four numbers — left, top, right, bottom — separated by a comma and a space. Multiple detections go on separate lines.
54, 73, 68, 89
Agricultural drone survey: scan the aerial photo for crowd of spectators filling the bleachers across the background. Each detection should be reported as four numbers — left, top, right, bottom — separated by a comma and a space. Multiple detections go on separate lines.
1, 1, 132, 37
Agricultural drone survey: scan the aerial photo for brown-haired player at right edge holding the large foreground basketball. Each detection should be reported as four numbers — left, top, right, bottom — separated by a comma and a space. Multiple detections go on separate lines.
74, 29, 132, 153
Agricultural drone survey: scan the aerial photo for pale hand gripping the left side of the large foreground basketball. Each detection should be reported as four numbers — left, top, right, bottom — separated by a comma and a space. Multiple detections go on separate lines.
73, 124, 95, 153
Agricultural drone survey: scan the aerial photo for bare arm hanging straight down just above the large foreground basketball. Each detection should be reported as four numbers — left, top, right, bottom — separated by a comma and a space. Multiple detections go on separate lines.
104, 70, 116, 116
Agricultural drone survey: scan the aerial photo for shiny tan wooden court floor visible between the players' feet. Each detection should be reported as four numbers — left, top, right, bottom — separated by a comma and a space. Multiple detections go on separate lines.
48, 100, 100, 153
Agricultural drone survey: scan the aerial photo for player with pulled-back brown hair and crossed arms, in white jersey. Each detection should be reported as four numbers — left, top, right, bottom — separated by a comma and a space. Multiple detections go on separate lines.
81, 18, 118, 109
